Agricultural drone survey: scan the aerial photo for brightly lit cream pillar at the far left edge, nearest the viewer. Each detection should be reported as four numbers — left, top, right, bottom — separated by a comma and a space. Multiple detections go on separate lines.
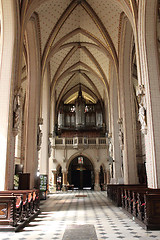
0, 0, 18, 190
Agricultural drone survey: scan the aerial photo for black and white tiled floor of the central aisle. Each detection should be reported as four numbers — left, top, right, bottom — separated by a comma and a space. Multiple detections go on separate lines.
0, 191, 160, 240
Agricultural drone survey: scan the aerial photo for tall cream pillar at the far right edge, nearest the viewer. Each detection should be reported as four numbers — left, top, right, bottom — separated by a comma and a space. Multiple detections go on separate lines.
138, 0, 160, 188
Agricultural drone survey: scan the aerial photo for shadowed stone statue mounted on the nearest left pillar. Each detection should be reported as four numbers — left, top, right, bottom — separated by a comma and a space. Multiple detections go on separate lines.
13, 88, 22, 136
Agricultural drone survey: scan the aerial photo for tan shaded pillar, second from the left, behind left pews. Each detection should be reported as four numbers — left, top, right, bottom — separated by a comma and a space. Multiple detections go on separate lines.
24, 20, 41, 188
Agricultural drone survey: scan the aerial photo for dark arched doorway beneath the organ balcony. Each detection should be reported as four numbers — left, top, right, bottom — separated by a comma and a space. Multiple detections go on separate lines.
68, 156, 94, 189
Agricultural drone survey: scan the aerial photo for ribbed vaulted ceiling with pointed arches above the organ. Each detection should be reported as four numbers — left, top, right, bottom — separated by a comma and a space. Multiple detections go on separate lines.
27, 0, 136, 106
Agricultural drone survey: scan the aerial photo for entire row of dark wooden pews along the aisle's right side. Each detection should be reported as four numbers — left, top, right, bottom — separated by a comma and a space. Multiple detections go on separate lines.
107, 185, 160, 230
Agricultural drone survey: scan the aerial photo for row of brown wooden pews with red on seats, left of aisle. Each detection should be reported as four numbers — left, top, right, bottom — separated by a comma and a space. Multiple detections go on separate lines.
0, 190, 40, 231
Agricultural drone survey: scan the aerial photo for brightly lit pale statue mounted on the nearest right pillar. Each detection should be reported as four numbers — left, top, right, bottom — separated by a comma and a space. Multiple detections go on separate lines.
137, 85, 147, 134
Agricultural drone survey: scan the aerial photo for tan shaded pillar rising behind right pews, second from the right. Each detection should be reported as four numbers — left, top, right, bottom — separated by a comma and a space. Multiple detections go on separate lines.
119, 17, 138, 184
